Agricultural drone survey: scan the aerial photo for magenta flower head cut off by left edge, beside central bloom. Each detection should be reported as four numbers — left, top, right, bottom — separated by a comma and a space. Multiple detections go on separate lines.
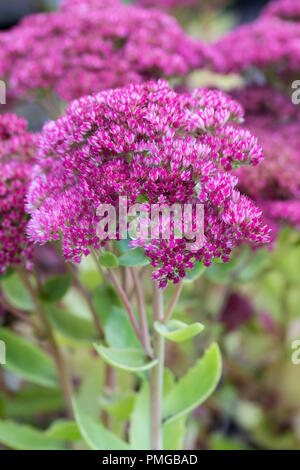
0, 114, 36, 273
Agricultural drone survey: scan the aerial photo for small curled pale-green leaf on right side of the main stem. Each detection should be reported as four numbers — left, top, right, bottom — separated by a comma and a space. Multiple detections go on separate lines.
154, 320, 204, 343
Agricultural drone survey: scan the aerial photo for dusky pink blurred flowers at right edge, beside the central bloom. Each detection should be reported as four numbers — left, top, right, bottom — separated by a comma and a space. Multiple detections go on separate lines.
234, 87, 300, 235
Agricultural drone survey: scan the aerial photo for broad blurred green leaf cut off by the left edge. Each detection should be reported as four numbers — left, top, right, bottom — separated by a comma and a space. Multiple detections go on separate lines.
0, 328, 58, 388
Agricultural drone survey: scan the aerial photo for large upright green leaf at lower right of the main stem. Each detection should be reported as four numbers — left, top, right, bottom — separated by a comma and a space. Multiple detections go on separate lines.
163, 343, 221, 421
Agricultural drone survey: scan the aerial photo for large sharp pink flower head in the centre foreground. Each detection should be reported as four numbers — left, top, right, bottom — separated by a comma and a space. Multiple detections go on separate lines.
27, 80, 269, 287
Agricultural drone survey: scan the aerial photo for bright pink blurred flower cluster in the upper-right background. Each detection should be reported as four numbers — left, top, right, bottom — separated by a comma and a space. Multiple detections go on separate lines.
214, 6, 300, 81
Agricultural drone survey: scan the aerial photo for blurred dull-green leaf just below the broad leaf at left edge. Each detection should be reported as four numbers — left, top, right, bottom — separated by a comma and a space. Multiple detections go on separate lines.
3, 386, 65, 419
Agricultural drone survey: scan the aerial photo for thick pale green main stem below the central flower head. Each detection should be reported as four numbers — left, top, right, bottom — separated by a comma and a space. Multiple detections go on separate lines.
150, 281, 165, 450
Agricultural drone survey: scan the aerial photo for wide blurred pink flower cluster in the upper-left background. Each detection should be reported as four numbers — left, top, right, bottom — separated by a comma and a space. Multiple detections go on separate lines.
0, 0, 211, 101
